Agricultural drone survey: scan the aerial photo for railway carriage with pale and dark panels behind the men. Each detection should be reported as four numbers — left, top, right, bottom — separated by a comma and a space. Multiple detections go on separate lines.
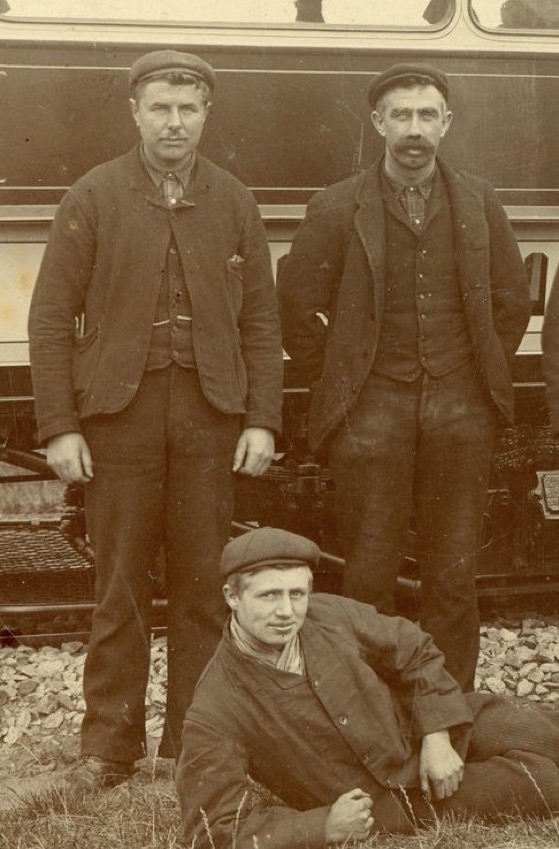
0, 0, 559, 624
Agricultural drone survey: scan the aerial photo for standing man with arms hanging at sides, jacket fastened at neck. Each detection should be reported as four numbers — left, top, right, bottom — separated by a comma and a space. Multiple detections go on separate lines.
29, 50, 282, 785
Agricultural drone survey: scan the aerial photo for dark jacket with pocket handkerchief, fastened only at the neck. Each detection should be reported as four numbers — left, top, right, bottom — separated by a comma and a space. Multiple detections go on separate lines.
29, 148, 282, 441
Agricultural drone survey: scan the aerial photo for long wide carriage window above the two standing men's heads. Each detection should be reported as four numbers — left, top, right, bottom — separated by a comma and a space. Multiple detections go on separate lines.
0, 0, 455, 28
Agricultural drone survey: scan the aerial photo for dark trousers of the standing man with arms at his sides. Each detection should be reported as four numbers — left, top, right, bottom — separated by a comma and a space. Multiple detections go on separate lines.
82, 365, 240, 762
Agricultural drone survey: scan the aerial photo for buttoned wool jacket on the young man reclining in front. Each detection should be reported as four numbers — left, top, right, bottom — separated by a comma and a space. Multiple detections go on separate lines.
177, 594, 472, 849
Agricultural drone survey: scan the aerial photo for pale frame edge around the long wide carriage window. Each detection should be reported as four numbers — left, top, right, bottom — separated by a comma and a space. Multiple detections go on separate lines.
0, 0, 459, 34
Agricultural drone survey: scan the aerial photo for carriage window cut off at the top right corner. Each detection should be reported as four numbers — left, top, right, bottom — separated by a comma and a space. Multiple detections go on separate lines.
471, 0, 559, 30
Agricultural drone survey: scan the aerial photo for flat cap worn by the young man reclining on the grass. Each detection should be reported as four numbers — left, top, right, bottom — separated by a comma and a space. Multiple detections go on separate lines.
221, 528, 320, 579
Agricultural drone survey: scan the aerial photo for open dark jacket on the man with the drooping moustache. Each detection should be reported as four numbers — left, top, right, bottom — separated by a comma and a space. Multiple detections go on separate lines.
278, 161, 530, 450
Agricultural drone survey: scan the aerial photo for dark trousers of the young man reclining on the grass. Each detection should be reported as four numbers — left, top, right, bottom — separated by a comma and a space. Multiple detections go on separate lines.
373, 693, 559, 834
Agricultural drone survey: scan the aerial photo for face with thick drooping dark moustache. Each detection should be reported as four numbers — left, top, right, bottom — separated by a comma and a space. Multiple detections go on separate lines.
372, 85, 452, 178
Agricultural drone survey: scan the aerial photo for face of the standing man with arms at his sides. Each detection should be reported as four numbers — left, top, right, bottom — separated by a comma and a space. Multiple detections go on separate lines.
131, 80, 208, 170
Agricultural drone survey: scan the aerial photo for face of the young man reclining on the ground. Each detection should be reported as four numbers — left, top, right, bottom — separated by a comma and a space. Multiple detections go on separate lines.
224, 566, 311, 649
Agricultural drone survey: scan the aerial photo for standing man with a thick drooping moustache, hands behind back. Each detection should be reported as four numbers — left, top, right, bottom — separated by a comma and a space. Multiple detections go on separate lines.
279, 64, 529, 690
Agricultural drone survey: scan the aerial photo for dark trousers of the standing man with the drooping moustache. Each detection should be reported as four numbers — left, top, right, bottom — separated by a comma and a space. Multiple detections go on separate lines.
329, 364, 495, 691
